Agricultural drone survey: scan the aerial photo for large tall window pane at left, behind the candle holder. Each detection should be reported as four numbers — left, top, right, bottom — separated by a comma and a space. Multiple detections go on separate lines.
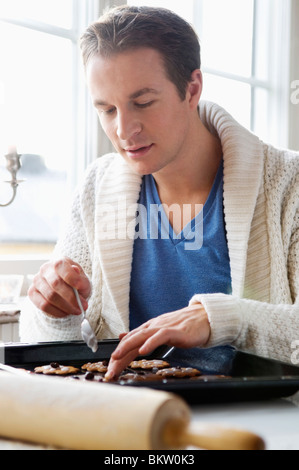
0, 23, 73, 248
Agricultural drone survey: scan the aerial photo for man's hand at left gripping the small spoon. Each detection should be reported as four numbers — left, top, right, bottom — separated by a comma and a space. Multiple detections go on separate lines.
28, 258, 91, 318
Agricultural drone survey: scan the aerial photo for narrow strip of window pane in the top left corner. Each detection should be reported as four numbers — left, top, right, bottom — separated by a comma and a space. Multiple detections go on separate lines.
0, 0, 73, 29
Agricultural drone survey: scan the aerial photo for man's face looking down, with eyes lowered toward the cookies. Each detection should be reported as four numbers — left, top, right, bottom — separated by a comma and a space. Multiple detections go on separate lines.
86, 48, 198, 175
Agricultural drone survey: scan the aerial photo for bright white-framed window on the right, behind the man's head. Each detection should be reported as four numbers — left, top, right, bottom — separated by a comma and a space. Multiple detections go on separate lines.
128, 0, 298, 148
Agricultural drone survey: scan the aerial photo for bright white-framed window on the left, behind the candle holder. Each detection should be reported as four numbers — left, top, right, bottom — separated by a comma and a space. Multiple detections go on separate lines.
0, 0, 100, 256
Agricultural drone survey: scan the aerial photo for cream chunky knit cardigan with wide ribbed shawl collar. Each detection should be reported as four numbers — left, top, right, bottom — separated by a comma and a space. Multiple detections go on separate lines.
20, 102, 299, 362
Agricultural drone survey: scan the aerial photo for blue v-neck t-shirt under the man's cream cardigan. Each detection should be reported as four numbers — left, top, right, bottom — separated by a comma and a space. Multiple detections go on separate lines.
130, 164, 231, 329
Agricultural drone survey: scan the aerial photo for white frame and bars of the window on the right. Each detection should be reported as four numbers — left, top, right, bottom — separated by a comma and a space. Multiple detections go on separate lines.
194, 0, 292, 148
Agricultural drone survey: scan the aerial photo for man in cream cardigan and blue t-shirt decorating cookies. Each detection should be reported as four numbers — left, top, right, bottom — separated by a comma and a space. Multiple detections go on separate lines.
21, 7, 299, 378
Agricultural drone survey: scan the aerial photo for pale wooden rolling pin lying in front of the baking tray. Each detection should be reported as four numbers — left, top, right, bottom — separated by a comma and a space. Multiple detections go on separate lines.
0, 372, 264, 450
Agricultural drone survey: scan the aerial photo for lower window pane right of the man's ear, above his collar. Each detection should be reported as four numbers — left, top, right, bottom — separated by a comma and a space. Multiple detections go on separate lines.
202, 74, 251, 128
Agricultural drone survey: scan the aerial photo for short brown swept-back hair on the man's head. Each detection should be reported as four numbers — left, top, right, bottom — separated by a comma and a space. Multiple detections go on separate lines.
80, 6, 201, 100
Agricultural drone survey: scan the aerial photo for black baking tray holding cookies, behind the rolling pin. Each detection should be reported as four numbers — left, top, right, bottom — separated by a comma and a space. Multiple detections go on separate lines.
0, 340, 299, 404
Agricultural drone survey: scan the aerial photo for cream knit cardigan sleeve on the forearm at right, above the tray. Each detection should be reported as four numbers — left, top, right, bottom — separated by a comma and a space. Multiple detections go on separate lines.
190, 218, 299, 363
